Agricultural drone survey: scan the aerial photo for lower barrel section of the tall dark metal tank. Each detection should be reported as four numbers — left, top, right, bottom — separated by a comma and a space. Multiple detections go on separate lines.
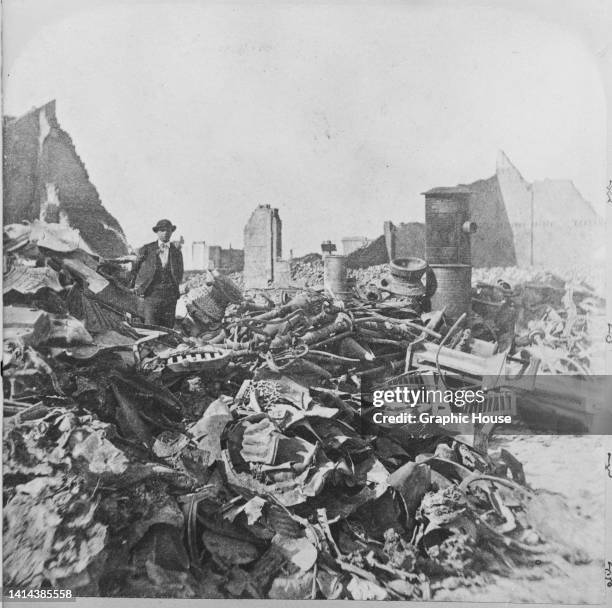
427, 264, 472, 320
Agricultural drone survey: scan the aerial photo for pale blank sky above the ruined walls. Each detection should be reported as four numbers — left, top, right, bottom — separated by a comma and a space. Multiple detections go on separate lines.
3, 0, 606, 262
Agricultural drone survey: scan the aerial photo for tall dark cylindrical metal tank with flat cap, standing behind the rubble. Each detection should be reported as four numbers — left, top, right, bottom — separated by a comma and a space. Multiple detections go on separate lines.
423, 186, 476, 320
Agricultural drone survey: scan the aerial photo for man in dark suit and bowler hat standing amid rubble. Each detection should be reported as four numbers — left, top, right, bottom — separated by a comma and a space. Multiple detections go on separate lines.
134, 220, 183, 327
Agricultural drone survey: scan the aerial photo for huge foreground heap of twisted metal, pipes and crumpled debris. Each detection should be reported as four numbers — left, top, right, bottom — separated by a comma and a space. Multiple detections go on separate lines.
4, 220, 604, 600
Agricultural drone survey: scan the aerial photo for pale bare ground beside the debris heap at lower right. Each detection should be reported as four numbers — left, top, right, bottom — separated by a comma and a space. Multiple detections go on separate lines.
434, 435, 612, 604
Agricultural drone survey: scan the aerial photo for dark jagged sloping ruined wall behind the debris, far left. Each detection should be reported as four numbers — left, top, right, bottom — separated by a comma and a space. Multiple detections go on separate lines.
3, 101, 128, 257
